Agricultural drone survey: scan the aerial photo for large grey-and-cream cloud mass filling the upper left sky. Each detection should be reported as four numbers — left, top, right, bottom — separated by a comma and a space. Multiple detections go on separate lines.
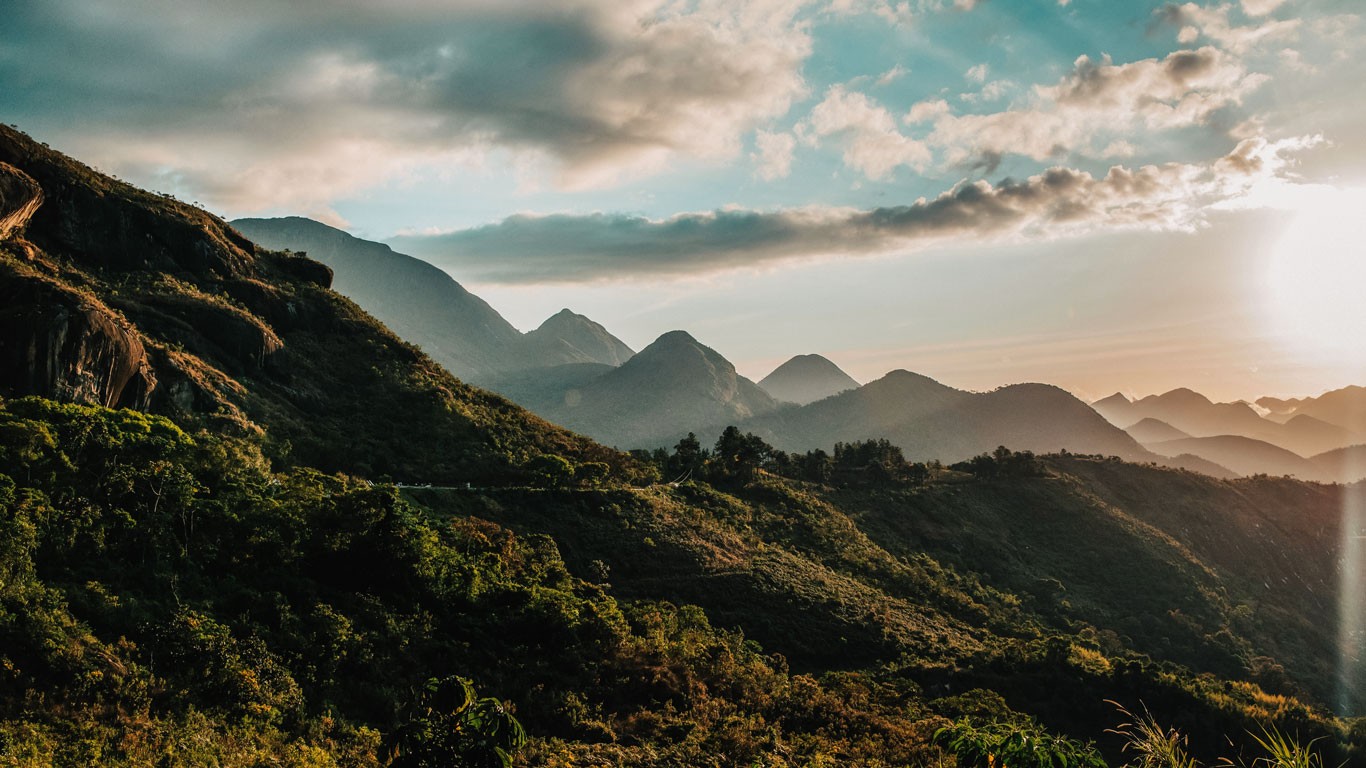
0, 0, 811, 212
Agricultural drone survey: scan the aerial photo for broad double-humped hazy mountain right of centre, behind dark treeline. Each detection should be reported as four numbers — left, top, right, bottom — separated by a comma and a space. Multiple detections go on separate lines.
742, 370, 1150, 462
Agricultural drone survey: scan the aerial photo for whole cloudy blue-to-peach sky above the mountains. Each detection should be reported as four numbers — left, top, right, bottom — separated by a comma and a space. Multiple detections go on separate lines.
0, 0, 1366, 400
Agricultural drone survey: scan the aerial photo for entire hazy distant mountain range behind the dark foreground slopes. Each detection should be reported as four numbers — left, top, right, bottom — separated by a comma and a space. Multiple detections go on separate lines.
234, 217, 1366, 480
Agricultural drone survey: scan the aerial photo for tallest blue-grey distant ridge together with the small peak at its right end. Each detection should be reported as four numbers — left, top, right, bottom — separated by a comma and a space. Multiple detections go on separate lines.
232, 216, 631, 385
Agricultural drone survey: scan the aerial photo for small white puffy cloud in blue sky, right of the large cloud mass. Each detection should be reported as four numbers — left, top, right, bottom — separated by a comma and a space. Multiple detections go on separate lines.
799, 86, 930, 179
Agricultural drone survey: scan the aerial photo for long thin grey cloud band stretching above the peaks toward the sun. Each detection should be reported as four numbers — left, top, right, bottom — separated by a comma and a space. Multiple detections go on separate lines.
391, 138, 1314, 284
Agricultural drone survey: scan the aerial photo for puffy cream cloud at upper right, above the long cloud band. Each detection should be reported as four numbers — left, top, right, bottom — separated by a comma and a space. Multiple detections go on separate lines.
923, 46, 1266, 164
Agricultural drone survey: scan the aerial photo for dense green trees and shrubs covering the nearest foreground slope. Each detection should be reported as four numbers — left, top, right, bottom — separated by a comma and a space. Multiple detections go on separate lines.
0, 398, 1366, 765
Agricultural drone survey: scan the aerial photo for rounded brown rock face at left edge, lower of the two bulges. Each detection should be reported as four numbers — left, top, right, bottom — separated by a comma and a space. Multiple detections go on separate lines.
0, 273, 156, 409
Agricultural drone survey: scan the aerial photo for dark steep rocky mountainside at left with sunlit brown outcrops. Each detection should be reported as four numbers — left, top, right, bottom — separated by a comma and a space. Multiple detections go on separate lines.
0, 126, 622, 481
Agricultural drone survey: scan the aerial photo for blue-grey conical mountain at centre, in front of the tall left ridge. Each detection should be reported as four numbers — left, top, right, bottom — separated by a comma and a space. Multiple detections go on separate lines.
537, 331, 779, 448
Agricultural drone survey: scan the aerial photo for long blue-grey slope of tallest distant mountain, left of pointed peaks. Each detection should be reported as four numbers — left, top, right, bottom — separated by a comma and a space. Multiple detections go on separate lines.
232, 216, 522, 381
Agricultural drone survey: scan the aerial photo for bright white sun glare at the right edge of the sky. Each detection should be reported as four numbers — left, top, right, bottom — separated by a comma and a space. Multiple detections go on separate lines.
1268, 187, 1366, 370
